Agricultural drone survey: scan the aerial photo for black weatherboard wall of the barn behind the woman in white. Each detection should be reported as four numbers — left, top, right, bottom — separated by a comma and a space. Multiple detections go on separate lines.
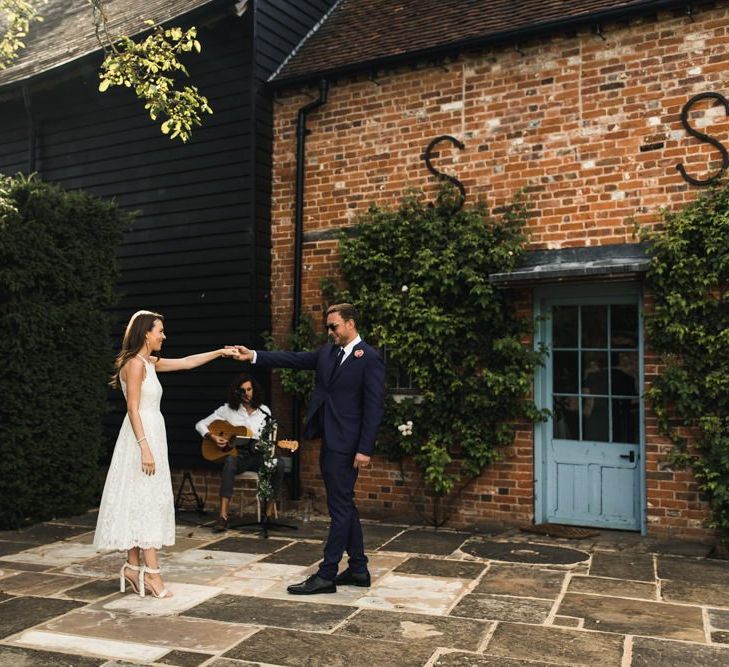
0, 0, 332, 468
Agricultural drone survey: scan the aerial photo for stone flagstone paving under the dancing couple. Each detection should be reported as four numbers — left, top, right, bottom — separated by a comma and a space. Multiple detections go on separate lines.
0, 512, 729, 667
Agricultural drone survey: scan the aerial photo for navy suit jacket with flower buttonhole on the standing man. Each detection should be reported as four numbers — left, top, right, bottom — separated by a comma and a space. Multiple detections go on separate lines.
256, 341, 385, 456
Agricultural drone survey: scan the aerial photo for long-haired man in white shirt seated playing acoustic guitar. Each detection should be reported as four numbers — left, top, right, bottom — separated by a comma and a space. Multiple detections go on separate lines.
195, 373, 284, 533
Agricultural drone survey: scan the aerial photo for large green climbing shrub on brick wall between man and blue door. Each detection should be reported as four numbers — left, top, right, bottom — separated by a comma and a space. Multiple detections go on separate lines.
328, 189, 542, 496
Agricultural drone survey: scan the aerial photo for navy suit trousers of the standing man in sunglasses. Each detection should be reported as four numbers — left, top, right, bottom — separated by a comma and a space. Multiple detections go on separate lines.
319, 439, 367, 581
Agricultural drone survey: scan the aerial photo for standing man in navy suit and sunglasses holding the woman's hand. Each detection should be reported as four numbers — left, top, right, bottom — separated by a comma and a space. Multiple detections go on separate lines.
238, 303, 385, 595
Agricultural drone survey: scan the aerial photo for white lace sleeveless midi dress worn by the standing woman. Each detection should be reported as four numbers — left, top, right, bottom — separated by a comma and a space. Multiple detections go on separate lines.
94, 357, 175, 551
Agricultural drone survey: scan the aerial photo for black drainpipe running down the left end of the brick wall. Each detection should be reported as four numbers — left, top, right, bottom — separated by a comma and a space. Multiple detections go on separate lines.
291, 79, 329, 500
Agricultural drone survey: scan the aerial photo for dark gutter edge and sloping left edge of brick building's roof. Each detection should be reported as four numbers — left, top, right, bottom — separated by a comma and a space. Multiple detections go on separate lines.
267, 0, 690, 90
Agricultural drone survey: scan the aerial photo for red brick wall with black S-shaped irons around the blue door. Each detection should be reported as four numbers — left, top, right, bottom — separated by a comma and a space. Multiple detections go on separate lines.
264, 3, 729, 537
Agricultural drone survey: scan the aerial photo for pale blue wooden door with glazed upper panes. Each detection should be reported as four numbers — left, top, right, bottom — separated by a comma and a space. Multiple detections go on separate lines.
538, 294, 643, 530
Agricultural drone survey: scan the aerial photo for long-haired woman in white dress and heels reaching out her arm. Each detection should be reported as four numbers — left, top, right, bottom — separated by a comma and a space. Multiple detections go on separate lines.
94, 310, 236, 598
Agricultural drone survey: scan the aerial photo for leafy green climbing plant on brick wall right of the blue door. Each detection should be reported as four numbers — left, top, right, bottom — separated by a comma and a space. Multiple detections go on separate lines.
643, 184, 729, 542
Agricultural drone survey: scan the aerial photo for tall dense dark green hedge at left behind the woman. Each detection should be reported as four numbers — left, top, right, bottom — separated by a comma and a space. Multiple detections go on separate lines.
0, 176, 130, 528
